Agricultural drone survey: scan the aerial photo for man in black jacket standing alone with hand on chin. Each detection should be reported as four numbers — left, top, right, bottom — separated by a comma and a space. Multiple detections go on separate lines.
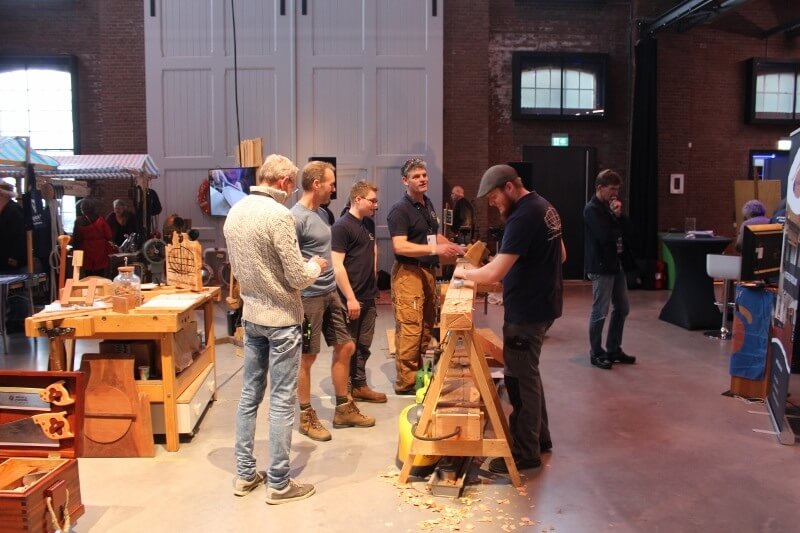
583, 169, 636, 370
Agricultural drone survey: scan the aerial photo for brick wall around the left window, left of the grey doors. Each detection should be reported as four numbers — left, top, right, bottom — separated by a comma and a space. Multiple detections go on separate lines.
0, 0, 147, 214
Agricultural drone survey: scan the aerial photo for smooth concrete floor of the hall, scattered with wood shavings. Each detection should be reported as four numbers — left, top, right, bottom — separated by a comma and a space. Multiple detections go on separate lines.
0, 284, 800, 533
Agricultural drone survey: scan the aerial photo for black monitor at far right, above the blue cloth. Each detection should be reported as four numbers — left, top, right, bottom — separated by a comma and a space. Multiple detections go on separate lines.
742, 224, 783, 281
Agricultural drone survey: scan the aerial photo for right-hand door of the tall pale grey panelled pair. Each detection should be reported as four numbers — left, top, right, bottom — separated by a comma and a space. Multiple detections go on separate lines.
296, 0, 443, 271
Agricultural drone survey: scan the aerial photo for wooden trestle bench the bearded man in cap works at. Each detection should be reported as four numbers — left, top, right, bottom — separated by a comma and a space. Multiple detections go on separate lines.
399, 260, 522, 487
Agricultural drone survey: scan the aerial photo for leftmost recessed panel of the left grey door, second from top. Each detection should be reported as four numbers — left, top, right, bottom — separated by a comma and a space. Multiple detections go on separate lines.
163, 70, 215, 157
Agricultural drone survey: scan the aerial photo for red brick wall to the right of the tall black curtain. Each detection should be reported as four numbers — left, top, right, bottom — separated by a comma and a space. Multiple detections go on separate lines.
658, 0, 800, 236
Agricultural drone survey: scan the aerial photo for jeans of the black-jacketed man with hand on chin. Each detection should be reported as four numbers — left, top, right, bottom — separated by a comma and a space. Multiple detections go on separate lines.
589, 266, 630, 357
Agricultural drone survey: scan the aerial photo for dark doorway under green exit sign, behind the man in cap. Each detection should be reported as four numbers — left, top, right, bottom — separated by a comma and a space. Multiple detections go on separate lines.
522, 146, 597, 279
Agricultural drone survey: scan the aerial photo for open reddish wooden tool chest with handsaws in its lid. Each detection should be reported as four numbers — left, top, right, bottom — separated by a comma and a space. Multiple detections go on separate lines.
0, 370, 84, 533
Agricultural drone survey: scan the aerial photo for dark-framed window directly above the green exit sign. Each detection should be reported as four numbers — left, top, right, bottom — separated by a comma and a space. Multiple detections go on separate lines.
512, 52, 608, 120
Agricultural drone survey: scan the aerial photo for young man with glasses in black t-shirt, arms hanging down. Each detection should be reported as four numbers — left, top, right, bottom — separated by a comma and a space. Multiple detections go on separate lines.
331, 180, 386, 403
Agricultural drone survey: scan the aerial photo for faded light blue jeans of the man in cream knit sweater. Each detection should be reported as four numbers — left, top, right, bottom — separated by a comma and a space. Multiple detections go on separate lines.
234, 322, 302, 489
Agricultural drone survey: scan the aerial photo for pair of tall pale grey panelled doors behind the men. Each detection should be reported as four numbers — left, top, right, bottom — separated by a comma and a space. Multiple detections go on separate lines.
144, 0, 443, 270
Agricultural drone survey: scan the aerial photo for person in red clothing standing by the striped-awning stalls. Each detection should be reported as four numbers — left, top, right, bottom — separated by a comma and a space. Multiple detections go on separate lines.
72, 198, 113, 277
